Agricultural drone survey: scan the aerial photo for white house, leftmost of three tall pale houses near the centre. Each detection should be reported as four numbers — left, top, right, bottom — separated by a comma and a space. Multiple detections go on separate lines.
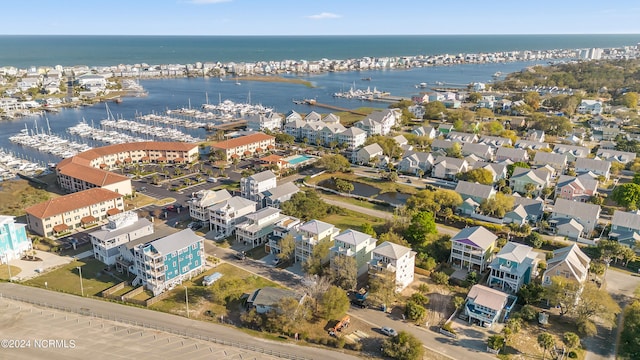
294, 220, 340, 263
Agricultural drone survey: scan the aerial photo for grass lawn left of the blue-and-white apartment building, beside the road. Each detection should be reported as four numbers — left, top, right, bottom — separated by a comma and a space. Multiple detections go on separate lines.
25, 259, 120, 296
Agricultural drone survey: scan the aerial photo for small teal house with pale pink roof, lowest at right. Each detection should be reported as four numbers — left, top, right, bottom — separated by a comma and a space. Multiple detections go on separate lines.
462, 284, 516, 328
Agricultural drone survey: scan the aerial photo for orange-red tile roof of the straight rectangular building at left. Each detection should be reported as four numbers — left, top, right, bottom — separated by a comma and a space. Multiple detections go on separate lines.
25, 188, 122, 219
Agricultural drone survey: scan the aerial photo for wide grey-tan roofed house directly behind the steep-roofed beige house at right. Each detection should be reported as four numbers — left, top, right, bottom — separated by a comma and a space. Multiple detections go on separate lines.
549, 199, 601, 239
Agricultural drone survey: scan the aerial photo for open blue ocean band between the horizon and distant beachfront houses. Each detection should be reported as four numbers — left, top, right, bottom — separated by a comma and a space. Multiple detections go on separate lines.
0, 34, 640, 68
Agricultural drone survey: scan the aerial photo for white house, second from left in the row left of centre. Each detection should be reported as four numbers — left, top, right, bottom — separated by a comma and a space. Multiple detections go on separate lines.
209, 196, 256, 239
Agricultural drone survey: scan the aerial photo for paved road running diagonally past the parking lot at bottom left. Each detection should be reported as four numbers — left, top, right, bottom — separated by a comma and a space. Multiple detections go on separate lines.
0, 283, 358, 359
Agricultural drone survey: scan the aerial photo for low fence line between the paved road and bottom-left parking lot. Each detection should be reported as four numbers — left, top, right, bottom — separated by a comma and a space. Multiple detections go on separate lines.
0, 293, 311, 360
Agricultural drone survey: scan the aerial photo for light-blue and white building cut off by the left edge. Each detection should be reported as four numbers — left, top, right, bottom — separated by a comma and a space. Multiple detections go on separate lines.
0, 215, 32, 264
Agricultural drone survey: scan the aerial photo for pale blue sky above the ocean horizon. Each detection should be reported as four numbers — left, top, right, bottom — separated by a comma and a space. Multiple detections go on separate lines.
0, 0, 640, 35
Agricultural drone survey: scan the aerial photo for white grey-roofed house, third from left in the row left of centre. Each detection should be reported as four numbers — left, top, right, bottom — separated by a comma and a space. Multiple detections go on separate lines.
236, 207, 286, 248
